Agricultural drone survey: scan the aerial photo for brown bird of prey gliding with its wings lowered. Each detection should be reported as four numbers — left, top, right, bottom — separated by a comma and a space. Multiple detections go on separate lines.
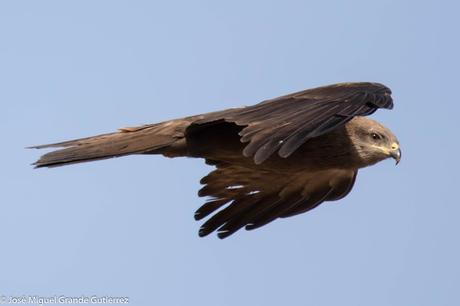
33, 83, 401, 238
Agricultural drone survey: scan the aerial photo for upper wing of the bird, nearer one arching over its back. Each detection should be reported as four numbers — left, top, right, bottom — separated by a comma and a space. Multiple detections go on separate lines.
192, 83, 393, 164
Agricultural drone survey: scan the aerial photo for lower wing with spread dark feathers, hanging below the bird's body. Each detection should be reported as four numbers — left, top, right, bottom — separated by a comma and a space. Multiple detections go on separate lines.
195, 161, 357, 238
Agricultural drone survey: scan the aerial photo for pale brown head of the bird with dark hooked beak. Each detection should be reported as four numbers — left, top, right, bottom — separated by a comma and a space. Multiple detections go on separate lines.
347, 117, 401, 167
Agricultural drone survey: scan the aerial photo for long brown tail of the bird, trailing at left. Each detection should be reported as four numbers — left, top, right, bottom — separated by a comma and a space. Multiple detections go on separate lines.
30, 120, 189, 168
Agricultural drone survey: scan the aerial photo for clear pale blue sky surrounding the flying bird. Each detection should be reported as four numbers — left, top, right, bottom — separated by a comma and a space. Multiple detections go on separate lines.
0, 0, 460, 306
